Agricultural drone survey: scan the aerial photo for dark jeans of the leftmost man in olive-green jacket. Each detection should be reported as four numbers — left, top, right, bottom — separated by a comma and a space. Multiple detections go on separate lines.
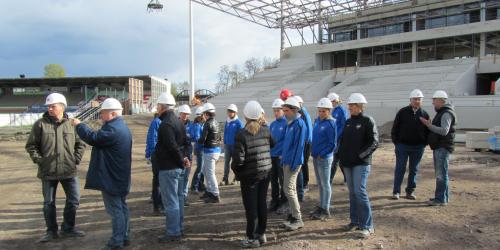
42, 177, 80, 232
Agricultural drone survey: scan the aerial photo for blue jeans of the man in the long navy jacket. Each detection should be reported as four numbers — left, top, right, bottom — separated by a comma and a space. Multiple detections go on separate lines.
102, 191, 130, 247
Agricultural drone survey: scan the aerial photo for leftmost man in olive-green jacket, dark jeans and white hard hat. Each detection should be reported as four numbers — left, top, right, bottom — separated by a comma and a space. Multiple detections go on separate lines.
26, 93, 85, 242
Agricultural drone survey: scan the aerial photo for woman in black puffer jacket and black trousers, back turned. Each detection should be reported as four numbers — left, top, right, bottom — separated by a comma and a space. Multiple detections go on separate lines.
231, 101, 274, 248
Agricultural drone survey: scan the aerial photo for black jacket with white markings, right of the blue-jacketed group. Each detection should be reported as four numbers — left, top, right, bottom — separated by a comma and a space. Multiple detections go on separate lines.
336, 113, 378, 167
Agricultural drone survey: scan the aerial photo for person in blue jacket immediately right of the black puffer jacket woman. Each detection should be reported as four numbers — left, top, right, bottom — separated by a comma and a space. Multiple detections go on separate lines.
269, 98, 287, 212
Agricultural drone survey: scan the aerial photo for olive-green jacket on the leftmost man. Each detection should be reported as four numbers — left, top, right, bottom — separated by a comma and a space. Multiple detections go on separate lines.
26, 113, 85, 180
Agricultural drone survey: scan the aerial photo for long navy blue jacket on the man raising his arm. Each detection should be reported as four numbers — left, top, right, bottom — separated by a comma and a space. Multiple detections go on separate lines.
76, 117, 132, 196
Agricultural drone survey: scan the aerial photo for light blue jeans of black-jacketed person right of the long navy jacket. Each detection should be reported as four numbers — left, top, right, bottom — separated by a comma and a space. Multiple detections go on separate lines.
160, 168, 184, 236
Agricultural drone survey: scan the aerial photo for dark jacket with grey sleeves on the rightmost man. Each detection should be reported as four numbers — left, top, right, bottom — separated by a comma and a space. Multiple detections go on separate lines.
428, 104, 457, 153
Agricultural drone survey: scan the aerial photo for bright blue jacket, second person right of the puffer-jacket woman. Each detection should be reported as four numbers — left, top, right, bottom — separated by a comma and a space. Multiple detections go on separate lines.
281, 115, 307, 171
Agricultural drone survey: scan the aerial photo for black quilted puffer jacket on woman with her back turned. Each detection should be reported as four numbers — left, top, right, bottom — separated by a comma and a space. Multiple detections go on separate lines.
231, 126, 274, 182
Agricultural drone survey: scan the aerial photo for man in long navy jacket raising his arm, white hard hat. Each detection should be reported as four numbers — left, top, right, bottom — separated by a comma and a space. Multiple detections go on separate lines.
73, 98, 132, 249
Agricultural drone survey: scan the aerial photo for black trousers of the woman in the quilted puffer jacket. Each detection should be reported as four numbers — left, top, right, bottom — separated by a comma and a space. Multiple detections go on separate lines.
240, 177, 269, 239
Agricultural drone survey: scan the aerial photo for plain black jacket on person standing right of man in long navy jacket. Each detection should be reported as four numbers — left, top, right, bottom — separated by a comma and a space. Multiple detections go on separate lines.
151, 111, 188, 170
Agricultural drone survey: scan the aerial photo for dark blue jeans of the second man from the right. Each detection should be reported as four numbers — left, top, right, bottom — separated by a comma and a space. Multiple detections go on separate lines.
392, 143, 425, 194
